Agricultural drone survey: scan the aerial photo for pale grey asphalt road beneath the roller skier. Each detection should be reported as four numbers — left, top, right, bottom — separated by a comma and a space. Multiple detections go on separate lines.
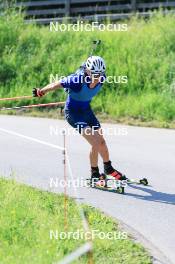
0, 116, 175, 264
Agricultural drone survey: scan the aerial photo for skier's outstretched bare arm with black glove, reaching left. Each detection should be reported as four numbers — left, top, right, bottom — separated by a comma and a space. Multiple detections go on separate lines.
33, 81, 63, 97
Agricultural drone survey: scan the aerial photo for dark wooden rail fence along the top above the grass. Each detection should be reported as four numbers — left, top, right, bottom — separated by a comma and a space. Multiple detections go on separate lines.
0, 0, 175, 24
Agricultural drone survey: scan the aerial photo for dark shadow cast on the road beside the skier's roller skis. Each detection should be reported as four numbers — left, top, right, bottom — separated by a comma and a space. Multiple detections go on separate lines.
126, 185, 175, 205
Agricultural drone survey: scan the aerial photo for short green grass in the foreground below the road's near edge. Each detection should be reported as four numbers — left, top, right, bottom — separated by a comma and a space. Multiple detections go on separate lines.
0, 178, 152, 264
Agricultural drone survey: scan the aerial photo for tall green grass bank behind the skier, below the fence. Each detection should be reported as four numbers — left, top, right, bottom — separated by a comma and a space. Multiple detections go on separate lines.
0, 9, 175, 126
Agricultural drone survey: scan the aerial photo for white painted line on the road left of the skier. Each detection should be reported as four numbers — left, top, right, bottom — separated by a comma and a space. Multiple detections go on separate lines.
0, 128, 64, 150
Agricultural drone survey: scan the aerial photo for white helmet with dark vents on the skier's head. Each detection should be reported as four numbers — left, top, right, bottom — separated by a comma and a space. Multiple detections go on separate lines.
86, 56, 106, 74
